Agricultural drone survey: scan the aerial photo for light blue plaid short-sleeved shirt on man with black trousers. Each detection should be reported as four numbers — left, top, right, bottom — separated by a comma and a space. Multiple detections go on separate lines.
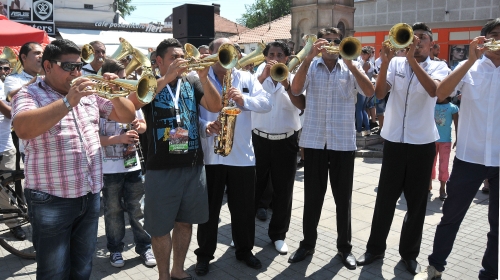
299, 58, 366, 151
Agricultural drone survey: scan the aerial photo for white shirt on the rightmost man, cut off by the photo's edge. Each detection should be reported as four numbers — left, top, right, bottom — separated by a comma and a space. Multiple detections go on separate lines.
456, 56, 500, 166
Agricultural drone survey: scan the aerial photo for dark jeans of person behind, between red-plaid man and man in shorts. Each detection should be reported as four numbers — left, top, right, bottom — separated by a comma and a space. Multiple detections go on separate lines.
102, 170, 151, 254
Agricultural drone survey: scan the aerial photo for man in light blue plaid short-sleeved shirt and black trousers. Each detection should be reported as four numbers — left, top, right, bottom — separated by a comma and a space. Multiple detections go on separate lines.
288, 27, 373, 269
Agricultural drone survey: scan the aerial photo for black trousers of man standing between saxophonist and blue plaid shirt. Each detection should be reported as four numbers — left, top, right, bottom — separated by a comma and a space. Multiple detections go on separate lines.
252, 133, 299, 242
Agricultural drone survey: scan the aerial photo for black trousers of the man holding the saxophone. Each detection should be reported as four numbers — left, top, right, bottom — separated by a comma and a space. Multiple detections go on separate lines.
194, 165, 255, 261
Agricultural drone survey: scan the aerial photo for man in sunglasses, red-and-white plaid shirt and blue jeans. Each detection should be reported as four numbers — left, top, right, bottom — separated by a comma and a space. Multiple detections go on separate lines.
12, 39, 134, 279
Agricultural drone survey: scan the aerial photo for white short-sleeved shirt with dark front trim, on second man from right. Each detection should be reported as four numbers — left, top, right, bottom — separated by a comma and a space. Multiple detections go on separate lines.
380, 57, 448, 144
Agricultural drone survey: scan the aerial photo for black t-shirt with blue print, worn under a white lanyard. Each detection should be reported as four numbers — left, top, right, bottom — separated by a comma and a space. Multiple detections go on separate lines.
143, 77, 203, 170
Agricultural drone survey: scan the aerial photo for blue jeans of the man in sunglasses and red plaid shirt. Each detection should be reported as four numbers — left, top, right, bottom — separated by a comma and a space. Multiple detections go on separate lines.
24, 189, 100, 280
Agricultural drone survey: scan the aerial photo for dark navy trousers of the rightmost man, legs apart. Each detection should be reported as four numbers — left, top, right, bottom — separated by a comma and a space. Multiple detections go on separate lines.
429, 158, 498, 279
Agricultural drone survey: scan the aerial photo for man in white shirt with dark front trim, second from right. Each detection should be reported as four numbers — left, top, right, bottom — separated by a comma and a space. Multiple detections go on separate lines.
358, 23, 448, 274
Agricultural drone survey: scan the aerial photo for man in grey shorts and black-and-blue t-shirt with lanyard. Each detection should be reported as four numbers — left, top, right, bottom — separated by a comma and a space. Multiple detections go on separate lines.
129, 38, 222, 280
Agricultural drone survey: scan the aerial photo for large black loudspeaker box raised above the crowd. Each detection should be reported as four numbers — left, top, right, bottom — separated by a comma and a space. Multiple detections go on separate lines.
172, 4, 215, 39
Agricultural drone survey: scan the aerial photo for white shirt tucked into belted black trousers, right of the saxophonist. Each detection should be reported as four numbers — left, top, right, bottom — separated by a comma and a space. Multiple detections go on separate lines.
252, 63, 301, 133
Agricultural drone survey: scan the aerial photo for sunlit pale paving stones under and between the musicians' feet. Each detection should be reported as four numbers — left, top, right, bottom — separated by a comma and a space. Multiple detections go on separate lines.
0, 151, 489, 280
